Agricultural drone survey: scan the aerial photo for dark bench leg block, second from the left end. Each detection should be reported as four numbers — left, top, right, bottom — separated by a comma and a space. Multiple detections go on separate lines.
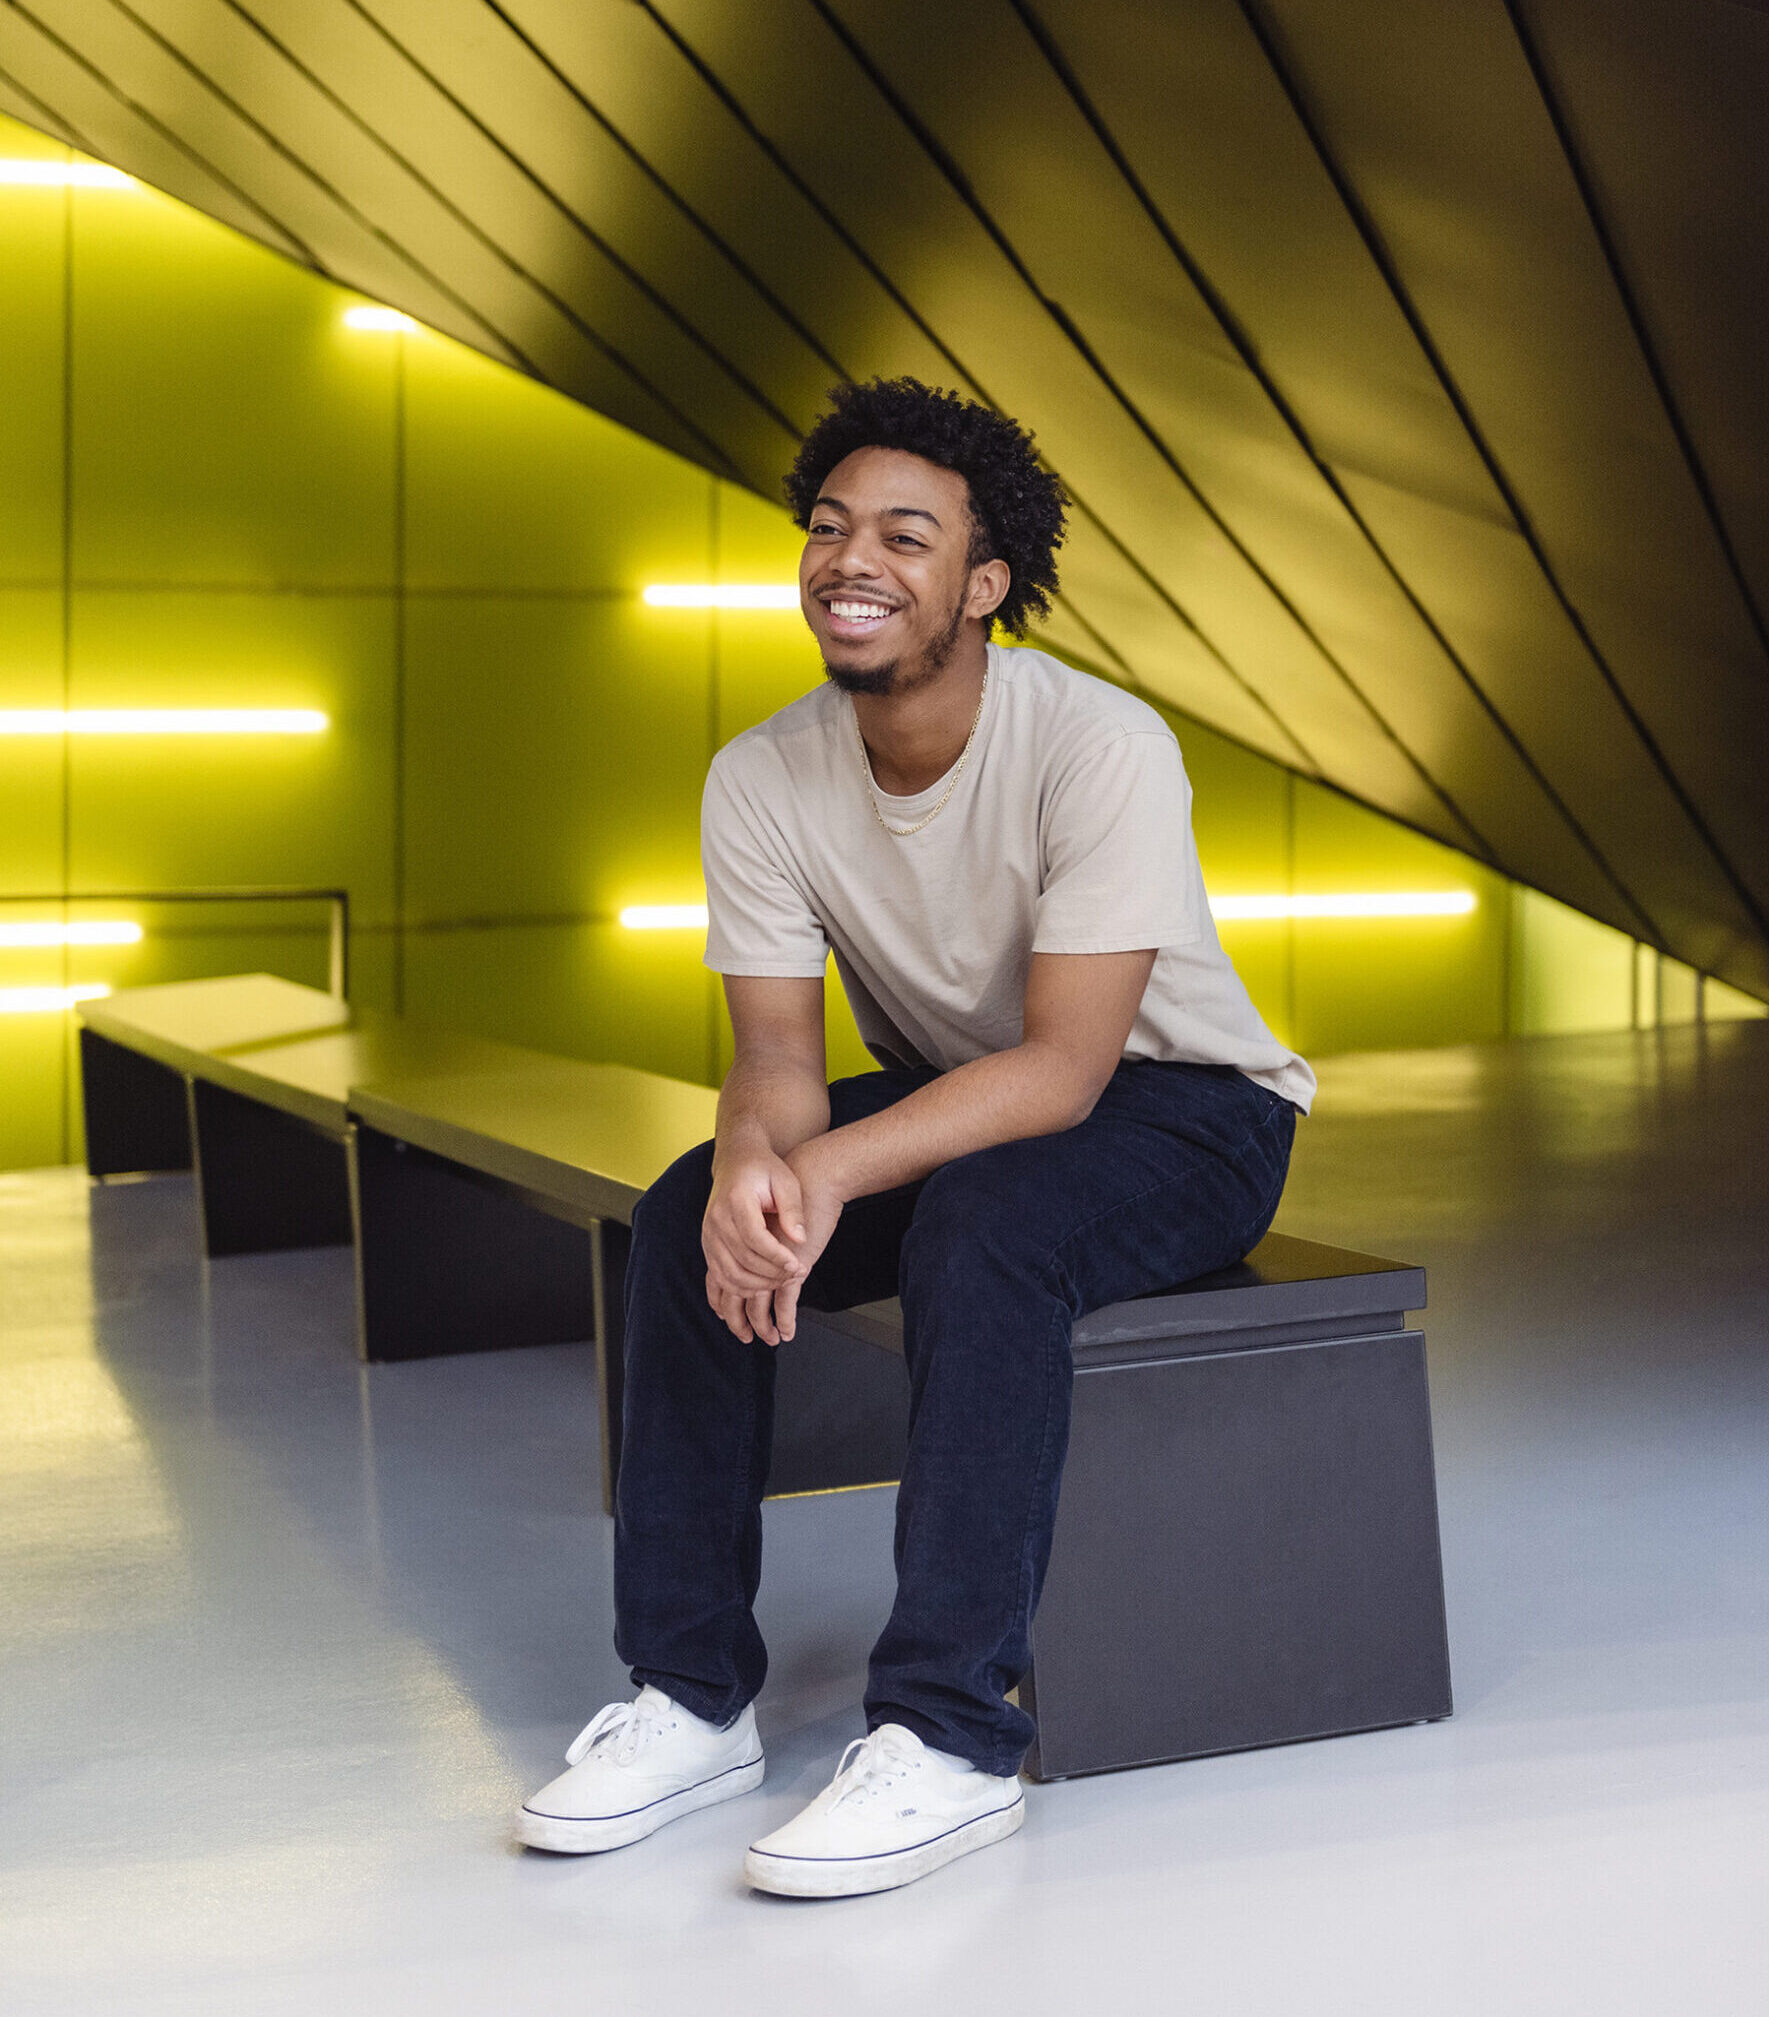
190, 1079, 351, 1261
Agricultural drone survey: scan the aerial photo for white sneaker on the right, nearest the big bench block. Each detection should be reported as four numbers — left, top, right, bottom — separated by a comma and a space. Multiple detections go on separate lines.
742, 1723, 1027, 1898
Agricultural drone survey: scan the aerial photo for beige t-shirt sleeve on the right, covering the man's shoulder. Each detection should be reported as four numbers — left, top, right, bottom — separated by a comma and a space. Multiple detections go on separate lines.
1033, 730, 1204, 952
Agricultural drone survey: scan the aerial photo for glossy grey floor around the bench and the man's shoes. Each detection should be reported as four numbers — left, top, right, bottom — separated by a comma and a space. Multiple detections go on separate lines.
0, 1025, 1769, 2017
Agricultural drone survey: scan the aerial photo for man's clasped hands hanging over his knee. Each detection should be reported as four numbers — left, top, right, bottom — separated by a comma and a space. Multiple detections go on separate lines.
700, 1136, 843, 1345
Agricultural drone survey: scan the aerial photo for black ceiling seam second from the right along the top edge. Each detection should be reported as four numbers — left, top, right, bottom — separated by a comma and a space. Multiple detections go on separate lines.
1236, 0, 1769, 942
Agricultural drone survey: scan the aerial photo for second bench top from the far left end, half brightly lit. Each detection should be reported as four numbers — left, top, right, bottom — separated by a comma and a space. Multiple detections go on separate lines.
188, 1013, 549, 1134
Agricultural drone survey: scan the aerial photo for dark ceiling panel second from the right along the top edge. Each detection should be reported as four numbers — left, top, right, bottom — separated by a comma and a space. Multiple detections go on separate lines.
1269, 0, 1769, 970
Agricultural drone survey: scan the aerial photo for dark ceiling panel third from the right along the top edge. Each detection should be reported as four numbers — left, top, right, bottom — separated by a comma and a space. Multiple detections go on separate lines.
1008, 0, 1749, 968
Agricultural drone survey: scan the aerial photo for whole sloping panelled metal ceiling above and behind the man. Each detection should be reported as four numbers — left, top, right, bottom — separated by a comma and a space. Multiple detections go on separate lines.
0, 0, 1769, 994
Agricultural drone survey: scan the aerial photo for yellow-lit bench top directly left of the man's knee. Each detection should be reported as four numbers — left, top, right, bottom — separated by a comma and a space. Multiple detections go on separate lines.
349, 1057, 718, 1220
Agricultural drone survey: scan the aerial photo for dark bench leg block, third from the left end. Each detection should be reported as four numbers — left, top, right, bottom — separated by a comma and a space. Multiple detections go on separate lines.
349, 1121, 595, 1359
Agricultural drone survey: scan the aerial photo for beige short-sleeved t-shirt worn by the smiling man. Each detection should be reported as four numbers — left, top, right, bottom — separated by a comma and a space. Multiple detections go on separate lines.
700, 643, 1315, 1113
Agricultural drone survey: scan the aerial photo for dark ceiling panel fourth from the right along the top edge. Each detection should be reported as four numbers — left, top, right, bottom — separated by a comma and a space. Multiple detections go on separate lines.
814, 0, 1650, 930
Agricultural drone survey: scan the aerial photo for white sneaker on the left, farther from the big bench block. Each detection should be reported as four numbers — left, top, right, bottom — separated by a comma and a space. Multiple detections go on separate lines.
516, 1686, 764, 1856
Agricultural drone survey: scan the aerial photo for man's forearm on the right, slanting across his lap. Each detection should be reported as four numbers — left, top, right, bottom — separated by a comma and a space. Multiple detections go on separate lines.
813, 1043, 1099, 1198
